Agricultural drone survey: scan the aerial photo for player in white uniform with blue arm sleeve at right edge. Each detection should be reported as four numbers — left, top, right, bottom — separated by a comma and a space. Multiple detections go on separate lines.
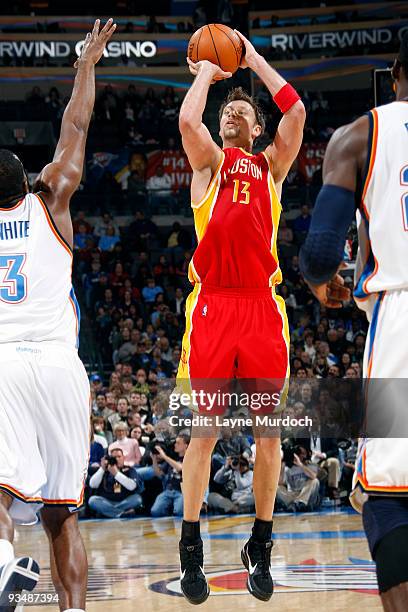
300, 33, 408, 612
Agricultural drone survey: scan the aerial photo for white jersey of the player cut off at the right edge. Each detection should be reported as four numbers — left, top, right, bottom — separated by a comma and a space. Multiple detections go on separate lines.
354, 102, 408, 316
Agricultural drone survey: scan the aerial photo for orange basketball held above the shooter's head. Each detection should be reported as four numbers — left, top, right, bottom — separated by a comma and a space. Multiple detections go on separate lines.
188, 23, 243, 73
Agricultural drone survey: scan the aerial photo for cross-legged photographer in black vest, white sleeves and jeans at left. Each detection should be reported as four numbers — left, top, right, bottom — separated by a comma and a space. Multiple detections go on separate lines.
88, 448, 143, 518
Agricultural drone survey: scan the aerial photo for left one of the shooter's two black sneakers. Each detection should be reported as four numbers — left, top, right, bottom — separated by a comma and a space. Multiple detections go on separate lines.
179, 542, 210, 605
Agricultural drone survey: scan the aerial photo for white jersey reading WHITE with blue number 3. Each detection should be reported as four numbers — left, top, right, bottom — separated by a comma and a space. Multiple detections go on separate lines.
0, 193, 79, 346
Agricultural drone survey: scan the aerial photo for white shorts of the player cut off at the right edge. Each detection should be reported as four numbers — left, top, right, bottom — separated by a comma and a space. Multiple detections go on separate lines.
350, 290, 408, 510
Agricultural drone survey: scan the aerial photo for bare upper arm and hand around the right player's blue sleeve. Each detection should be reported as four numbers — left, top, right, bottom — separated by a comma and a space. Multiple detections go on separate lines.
307, 115, 369, 308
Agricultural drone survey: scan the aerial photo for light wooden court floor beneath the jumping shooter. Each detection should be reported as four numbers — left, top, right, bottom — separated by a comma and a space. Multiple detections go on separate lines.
16, 511, 382, 612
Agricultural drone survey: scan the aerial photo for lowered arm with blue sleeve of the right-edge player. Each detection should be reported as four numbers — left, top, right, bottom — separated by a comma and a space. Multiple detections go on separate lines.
300, 116, 368, 308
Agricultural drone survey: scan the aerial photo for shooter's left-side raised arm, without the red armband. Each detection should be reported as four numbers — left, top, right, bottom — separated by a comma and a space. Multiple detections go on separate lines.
179, 59, 231, 171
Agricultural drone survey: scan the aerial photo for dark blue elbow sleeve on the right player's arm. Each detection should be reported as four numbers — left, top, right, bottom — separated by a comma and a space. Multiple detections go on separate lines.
299, 185, 356, 285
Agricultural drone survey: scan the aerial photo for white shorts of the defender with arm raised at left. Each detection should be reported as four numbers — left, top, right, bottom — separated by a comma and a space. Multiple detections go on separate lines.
0, 342, 90, 524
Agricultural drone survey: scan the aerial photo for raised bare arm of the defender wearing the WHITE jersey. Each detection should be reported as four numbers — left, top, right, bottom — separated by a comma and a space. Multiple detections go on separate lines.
34, 19, 116, 247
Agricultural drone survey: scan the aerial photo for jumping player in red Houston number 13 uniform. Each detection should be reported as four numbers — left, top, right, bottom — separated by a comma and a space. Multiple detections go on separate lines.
178, 28, 305, 604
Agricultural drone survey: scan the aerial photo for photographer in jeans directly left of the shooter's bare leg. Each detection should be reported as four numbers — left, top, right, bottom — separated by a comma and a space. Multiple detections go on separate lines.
150, 433, 190, 516
